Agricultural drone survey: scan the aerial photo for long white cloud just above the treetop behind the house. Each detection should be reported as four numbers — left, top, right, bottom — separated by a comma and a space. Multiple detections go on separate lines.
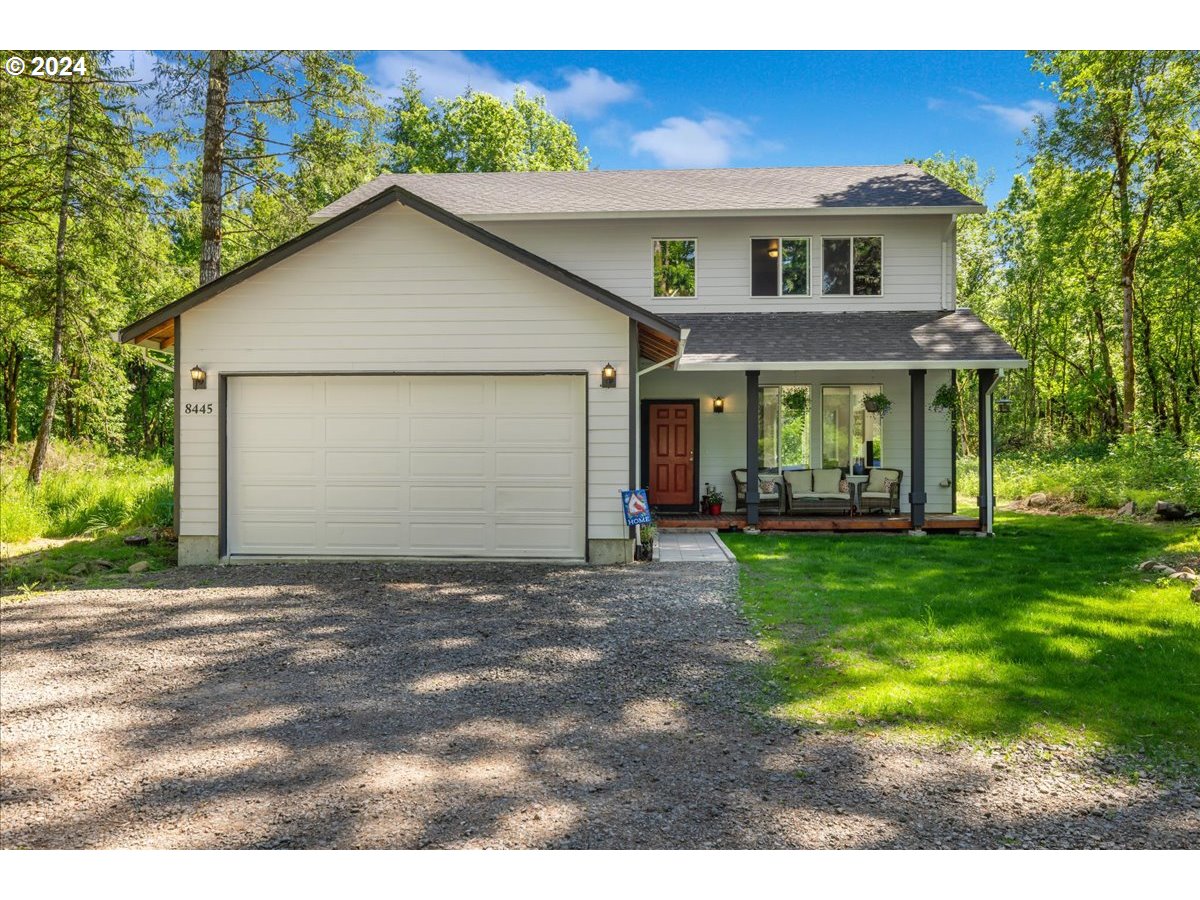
374, 50, 637, 119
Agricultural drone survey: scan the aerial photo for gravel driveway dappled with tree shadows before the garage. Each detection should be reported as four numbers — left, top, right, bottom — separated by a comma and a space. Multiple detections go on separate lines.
0, 563, 1200, 847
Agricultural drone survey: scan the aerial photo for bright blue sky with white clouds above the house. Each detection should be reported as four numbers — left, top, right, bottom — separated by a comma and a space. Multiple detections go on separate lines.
359, 50, 1052, 203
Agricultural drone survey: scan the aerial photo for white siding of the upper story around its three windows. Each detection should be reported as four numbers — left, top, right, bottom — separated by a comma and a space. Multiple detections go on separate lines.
485, 215, 953, 316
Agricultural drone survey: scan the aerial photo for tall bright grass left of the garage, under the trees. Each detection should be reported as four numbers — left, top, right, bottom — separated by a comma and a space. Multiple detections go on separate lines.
0, 442, 173, 544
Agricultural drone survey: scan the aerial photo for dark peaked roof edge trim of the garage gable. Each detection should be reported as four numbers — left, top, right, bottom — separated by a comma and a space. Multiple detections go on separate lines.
124, 185, 679, 343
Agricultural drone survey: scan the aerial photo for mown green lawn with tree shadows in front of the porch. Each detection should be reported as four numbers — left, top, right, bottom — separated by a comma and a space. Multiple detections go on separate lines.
725, 514, 1200, 764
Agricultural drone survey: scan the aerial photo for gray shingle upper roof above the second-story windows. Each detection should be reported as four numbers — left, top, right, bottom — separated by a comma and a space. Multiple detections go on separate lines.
312, 166, 983, 220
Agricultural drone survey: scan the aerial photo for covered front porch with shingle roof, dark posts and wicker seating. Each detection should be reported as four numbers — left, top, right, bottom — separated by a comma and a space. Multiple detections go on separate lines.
636, 310, 1024, 534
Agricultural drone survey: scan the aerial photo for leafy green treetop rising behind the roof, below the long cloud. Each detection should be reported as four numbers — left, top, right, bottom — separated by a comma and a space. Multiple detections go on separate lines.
388, 72, 590, 173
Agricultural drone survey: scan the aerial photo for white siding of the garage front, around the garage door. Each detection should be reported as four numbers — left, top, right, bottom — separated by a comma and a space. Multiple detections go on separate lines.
176, 205, 630, 539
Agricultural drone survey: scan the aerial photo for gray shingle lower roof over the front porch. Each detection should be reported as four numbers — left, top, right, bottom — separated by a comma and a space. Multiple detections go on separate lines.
667, 308, 1025, 368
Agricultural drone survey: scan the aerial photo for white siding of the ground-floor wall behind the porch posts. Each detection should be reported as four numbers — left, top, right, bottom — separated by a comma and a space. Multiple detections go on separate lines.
641, 370, 954, 512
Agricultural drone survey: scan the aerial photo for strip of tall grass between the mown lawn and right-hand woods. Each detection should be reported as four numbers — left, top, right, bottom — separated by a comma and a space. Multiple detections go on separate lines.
959, 434, 1200, 512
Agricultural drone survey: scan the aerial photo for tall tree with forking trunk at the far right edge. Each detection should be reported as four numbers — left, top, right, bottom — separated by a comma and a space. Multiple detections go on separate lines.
1032, 50, 1200, 433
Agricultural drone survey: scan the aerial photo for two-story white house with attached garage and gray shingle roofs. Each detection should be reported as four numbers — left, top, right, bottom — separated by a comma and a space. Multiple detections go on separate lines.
119, 166, 1025, 564
